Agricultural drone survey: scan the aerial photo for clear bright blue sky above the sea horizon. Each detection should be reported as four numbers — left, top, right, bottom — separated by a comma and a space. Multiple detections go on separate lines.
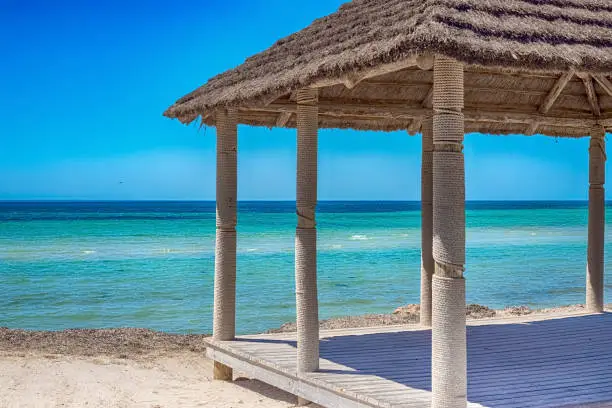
0, 0, 604, 200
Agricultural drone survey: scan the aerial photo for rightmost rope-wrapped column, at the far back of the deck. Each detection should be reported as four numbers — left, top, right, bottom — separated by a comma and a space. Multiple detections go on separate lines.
586, 126, 606, 313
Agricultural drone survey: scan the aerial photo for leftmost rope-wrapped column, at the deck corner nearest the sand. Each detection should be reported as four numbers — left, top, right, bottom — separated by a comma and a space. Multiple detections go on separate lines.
213, 109, 238, 381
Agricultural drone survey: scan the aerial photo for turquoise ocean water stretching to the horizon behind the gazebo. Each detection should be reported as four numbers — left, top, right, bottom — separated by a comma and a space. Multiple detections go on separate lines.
0, 202, 612, 333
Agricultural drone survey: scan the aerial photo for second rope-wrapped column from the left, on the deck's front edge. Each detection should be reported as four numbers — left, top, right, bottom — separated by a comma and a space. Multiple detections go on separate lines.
295, 89, 319, 373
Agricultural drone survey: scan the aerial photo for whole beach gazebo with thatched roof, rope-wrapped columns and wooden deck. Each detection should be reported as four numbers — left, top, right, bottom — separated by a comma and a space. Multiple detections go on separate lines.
165, 0, 612, 408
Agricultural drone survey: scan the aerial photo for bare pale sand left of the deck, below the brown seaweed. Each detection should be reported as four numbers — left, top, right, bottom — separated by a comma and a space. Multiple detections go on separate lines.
0, 353, 310, 408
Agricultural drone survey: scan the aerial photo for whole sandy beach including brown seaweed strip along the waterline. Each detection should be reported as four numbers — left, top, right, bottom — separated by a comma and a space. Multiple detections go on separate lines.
0, 305, 610, 408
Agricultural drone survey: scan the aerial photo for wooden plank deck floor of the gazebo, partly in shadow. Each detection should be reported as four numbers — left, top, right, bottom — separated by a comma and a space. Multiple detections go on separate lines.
207, 313, 612, 408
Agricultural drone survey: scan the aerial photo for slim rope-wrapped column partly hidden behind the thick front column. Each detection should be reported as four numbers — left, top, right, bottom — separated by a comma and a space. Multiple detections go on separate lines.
421, 118, 435, 327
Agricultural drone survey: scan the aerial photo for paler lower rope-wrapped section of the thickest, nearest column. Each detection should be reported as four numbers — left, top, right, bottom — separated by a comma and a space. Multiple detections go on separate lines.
431, 275, 467, 408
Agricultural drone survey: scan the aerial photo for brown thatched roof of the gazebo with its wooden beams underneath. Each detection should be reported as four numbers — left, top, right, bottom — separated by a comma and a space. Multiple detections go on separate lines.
165, 0, 612, 136
